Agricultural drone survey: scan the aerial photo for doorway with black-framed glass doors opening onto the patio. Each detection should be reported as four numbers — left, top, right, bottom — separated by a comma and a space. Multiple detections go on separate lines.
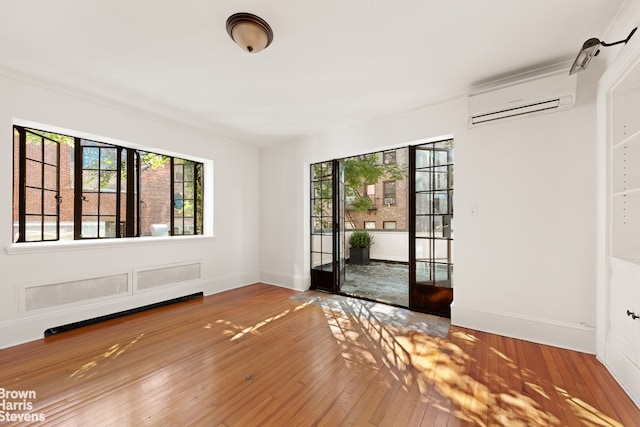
310, 140, 453, 317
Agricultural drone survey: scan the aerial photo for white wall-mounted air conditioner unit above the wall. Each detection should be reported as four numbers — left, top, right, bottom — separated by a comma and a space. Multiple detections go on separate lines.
467, 72, 576, 127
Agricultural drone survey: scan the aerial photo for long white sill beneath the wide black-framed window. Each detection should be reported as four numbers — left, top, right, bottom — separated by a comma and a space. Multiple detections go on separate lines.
7, 235, 215, 255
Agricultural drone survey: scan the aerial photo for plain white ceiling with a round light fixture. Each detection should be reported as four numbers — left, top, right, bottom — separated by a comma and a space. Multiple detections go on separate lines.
0, 0, 623, 145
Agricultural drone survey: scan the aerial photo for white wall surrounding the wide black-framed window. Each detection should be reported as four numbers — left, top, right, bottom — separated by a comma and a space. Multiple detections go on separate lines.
0, 70, 260, 348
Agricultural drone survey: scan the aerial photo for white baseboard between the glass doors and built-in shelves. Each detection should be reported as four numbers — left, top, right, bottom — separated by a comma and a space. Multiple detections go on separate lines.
451, 303, 596, 354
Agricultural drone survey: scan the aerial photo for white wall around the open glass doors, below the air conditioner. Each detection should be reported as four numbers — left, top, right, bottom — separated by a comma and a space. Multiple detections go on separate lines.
261, 67, 602, 353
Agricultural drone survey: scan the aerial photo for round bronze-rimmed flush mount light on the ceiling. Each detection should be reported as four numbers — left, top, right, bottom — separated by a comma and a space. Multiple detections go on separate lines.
227, 13, 273, 53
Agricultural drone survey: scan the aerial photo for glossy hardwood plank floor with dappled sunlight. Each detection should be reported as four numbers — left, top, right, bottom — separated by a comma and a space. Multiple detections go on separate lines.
0, 284, 640, 426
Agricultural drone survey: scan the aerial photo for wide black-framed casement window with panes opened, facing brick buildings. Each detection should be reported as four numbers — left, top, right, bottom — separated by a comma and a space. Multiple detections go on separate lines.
13, 126, 203, 242
